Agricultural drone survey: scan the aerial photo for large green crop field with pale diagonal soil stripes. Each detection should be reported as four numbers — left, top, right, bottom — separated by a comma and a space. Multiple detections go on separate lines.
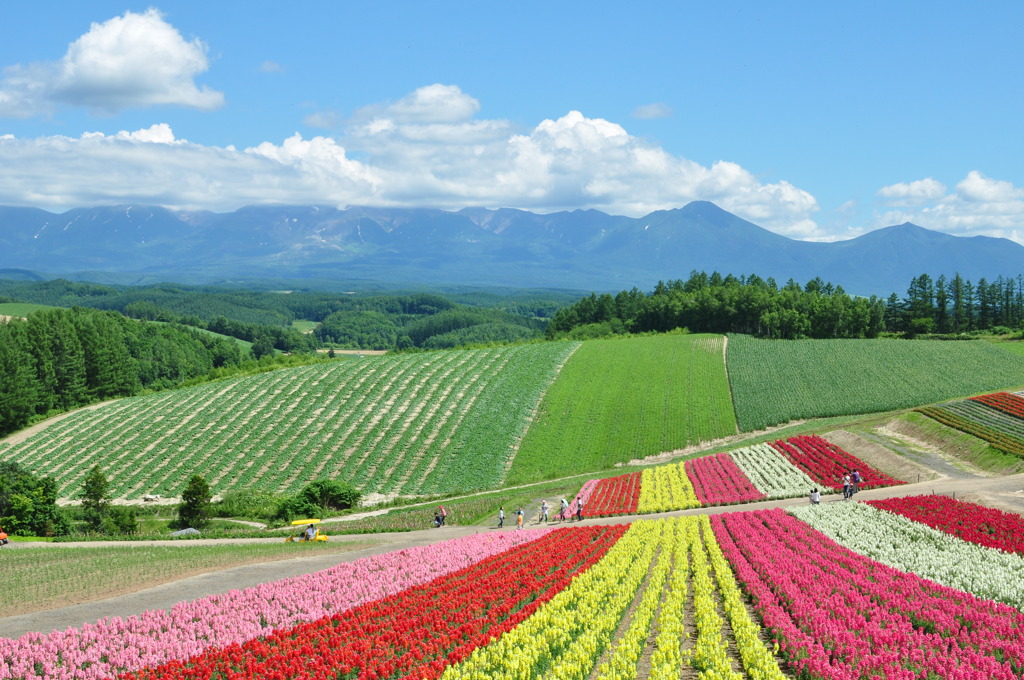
0, 342, 578, 498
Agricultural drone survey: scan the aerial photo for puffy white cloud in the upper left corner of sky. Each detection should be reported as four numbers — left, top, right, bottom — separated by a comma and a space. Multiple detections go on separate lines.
0, 9, 224, 117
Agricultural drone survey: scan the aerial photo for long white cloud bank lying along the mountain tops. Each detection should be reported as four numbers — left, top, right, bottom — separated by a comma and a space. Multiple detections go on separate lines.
0, 85, 825, 239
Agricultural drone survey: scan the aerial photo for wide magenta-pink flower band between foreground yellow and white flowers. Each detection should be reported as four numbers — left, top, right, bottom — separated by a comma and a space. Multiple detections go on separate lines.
712, 510, 1024, 680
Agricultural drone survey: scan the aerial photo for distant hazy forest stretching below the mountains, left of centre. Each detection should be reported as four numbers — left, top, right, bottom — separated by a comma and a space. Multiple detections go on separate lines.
0, 279, 565, 352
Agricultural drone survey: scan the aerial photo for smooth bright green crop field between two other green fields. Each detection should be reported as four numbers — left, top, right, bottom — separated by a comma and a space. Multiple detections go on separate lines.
507, 334, 736, 484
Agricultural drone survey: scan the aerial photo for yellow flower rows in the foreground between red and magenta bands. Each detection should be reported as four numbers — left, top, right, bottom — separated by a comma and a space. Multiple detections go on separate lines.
442, 516, 783, 680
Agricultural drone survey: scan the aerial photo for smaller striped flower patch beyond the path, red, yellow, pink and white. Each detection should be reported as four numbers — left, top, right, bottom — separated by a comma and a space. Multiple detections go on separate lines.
585, 435, 903, 517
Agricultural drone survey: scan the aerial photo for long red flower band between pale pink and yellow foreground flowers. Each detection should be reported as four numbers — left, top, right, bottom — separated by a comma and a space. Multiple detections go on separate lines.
122, 525, 627, 680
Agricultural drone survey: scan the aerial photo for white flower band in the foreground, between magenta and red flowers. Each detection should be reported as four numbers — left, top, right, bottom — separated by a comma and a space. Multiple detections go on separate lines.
790, 503, 1024, 609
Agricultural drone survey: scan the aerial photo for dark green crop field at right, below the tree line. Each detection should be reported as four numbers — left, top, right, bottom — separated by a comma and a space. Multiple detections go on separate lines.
728, 336, 1024, 431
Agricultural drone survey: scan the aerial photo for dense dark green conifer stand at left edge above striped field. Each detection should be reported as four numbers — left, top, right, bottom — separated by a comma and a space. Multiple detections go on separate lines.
0, 307, 251, 435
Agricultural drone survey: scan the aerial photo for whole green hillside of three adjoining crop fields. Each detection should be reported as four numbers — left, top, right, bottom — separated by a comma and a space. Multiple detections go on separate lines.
9, 334, 1024, 499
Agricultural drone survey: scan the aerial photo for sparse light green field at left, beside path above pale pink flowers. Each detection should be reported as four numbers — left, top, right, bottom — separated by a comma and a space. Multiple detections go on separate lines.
0, 540, 373, 617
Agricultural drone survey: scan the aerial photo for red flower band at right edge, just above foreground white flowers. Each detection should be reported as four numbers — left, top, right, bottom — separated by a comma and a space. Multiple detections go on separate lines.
866, 496, 1024, 555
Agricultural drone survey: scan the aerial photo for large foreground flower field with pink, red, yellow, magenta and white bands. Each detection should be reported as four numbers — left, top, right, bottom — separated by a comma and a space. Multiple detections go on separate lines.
6, 497, 1024, 680
